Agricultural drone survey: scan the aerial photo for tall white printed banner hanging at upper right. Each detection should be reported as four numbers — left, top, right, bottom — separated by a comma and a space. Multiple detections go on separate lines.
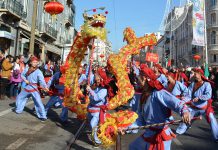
191, 0, 205, 46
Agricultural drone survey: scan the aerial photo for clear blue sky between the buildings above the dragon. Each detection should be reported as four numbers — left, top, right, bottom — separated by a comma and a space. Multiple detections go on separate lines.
74, 0, 180, 51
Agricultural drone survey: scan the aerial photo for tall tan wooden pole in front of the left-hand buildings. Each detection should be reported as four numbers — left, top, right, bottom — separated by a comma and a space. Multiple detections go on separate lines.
29, 0, 38, 55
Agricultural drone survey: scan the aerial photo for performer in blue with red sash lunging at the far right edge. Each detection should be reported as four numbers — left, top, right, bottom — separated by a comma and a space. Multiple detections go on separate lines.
176, 69, 218, 142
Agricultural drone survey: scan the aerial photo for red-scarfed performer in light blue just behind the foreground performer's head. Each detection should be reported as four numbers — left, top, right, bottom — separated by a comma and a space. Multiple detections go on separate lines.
153, 64, 167, 88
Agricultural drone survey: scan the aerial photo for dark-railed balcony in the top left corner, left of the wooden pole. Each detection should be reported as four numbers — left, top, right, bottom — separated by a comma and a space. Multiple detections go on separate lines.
0, 0, 27, 21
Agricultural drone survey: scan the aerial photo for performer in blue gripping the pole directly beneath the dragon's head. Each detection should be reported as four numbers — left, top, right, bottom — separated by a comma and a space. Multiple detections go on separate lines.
87, 74, 107, 146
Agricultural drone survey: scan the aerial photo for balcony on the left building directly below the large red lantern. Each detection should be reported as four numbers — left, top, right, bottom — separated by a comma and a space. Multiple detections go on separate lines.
39, 23, 58, 41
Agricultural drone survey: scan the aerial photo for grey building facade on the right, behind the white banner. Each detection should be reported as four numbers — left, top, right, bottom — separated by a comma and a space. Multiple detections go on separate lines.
164, 0, 218, 67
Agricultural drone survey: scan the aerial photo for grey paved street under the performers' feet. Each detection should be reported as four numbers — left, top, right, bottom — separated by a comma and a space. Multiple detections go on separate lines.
0, 100, 218, 150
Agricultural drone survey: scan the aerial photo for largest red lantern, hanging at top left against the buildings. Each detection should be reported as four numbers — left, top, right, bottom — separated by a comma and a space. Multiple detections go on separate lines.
44, 1, 64, 15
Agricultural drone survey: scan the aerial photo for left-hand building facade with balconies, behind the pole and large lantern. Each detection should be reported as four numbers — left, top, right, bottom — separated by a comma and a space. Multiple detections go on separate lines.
0, 0, 75, 61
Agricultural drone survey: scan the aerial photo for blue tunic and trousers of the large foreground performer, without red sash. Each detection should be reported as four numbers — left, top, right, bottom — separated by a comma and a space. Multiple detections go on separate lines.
129, 90, 188, 150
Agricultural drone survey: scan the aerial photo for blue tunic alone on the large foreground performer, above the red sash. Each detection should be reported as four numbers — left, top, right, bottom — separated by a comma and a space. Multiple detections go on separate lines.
137, 90, 185, 128
